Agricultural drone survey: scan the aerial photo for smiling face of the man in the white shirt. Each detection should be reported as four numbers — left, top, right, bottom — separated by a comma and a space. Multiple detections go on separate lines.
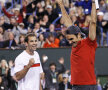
27, 36, 37, 51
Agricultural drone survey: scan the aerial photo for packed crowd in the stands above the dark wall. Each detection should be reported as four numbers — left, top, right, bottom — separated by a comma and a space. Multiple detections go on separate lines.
0, 0, 108, 49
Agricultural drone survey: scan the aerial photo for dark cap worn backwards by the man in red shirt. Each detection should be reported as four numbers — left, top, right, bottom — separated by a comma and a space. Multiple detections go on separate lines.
66, 25, 86, 38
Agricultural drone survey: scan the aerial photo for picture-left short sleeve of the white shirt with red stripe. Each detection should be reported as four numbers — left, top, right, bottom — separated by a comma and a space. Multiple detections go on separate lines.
14, 58, 24, 73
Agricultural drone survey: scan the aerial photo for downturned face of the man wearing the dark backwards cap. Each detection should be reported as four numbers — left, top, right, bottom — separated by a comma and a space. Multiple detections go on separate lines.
66, 34, 81, 47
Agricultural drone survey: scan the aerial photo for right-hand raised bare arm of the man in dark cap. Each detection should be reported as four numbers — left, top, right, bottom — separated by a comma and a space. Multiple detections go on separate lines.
89, 0, 97, 41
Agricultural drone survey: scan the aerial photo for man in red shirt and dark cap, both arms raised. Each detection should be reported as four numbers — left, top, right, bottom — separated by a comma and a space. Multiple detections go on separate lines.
57, 0, 97, 90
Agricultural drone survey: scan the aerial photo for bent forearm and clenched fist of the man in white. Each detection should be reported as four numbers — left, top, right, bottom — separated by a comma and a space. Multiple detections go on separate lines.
15, 58, 34, 80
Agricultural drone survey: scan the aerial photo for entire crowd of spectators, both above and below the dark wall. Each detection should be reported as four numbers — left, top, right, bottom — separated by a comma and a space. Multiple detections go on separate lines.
0, 0, 108, 90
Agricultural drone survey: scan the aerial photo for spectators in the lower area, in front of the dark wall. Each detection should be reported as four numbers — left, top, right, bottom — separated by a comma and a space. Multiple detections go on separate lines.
0, 55, 108, 90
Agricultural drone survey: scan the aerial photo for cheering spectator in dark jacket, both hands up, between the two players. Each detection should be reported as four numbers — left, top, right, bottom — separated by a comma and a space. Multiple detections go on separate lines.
43, 57, 65, 90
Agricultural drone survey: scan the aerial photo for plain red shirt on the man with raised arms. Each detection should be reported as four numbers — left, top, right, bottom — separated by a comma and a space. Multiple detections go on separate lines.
71, 38, 97, 85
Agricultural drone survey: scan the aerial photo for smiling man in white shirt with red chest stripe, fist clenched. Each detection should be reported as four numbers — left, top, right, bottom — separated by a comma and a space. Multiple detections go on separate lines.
14, 33, 43, 90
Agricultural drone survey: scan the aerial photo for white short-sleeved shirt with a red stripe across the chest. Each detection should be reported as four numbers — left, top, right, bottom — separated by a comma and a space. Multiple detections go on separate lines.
14, 50, 43, 90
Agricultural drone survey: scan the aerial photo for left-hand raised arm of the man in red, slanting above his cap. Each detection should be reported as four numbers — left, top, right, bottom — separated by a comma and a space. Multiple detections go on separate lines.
56, 0, 72, 27
